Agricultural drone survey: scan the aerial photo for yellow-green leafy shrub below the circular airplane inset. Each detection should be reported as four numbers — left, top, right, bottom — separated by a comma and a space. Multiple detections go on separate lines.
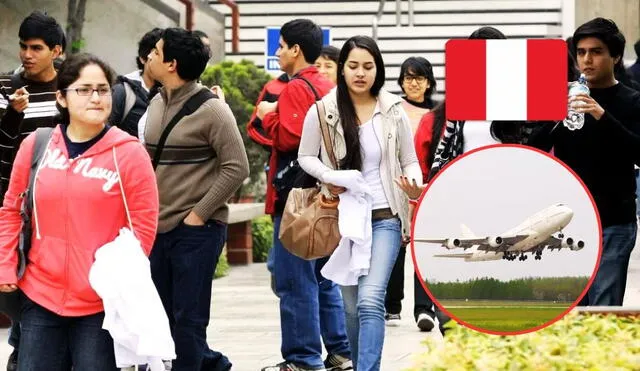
410, 312, 640, 371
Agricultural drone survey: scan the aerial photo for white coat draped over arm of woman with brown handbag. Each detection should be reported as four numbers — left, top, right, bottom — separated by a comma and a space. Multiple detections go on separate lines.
320, 170, 373, 286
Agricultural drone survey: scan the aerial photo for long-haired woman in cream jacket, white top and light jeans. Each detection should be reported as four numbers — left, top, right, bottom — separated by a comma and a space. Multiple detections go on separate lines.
298, 36, 422, 371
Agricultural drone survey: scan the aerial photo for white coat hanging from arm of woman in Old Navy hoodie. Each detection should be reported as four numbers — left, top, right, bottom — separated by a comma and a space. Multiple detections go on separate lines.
89, 228, 176, 371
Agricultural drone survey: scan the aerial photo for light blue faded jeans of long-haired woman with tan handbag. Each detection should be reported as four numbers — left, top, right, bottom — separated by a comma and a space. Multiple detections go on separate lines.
341, 218, 401, 371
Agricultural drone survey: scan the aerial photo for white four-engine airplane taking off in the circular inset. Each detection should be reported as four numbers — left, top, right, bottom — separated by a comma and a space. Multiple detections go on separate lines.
414, 204, 585, 262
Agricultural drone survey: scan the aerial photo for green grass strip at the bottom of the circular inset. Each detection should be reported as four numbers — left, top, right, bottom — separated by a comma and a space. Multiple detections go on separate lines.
439, 300, 571, 332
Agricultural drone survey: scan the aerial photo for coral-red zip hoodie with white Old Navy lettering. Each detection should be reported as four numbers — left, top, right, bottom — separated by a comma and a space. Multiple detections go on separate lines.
0, 126, 159, 316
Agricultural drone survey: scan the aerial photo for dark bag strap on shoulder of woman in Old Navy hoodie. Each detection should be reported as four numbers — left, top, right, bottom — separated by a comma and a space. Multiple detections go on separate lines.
18, 128, 53, 278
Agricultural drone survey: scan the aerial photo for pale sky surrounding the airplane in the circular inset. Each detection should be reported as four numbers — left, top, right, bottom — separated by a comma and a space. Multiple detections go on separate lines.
414, 146, 599, 282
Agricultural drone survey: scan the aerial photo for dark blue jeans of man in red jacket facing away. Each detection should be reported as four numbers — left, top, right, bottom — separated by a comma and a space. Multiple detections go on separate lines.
272, 216, 351, 369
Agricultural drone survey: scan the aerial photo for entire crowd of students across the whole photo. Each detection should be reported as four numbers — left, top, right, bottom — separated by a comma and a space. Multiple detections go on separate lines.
0, 7, 640, 371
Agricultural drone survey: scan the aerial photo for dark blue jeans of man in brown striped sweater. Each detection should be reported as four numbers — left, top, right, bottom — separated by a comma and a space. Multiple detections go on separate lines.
149, 220, 231, 371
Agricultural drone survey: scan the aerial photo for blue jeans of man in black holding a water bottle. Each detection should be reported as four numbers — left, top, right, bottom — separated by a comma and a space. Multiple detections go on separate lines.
587, 222, 638, 306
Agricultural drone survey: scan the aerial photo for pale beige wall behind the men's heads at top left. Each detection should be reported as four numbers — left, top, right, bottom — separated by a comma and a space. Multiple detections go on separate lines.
0, 0, 224, 74
